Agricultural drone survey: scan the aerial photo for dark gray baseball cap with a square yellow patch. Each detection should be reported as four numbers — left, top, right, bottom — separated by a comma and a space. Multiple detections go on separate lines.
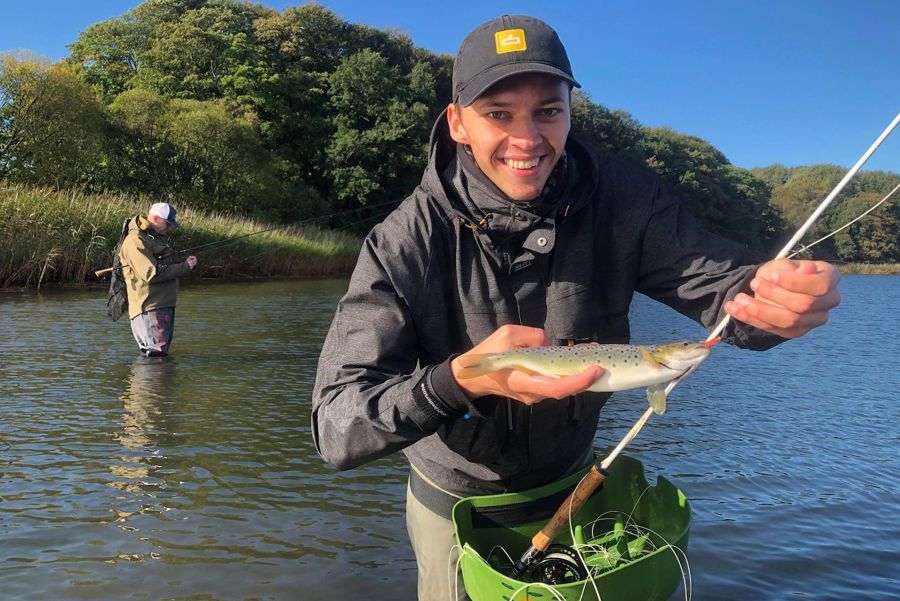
453, 15, 581, 106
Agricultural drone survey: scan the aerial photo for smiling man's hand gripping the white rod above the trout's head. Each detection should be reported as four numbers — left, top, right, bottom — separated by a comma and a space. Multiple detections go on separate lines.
725, 259, 841, 338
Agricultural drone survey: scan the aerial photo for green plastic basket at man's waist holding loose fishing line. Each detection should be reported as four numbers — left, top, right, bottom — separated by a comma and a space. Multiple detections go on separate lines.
453, 456, 691, 601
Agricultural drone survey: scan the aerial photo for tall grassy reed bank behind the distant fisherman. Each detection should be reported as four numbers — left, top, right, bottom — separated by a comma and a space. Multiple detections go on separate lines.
0, 182, 360, 288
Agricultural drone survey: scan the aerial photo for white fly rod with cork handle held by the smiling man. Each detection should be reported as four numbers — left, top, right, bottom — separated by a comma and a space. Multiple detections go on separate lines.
511, 113, 900, 580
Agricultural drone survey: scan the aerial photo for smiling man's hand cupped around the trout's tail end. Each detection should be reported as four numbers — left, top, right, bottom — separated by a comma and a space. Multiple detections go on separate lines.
450, 325, 603, 405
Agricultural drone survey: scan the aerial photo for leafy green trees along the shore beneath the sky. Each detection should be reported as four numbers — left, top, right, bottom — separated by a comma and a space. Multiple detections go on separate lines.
0, 0, 900, 262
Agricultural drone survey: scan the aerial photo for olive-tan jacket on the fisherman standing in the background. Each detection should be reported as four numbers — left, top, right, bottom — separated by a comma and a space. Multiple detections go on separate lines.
119, 216, 191, 319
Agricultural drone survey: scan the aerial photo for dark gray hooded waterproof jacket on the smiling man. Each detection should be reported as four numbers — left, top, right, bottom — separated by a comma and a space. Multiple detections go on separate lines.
312, 115, 782, 496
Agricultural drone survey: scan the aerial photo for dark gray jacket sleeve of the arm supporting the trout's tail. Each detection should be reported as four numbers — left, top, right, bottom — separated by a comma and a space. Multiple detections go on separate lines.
312, 236, 471, 469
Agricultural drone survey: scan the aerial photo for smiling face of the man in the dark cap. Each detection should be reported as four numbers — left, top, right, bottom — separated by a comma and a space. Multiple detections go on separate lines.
447, 74, 570, 200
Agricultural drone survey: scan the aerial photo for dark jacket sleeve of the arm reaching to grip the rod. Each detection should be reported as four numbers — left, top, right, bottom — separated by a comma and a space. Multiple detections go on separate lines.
637, 176, 785, 350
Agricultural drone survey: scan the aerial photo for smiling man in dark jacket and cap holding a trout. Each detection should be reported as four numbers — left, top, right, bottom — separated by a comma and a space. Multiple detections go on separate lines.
312, 16, 839, 600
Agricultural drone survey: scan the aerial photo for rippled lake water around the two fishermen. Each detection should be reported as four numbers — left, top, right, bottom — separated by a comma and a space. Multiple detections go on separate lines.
0, 276, 900, 600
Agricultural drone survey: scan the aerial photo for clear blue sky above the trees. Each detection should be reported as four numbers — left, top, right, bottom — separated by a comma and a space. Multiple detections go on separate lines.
0, 0, 900, 173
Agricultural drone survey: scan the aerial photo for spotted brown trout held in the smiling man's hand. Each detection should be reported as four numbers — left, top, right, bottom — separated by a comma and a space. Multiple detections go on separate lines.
459, 338, 719, 415
